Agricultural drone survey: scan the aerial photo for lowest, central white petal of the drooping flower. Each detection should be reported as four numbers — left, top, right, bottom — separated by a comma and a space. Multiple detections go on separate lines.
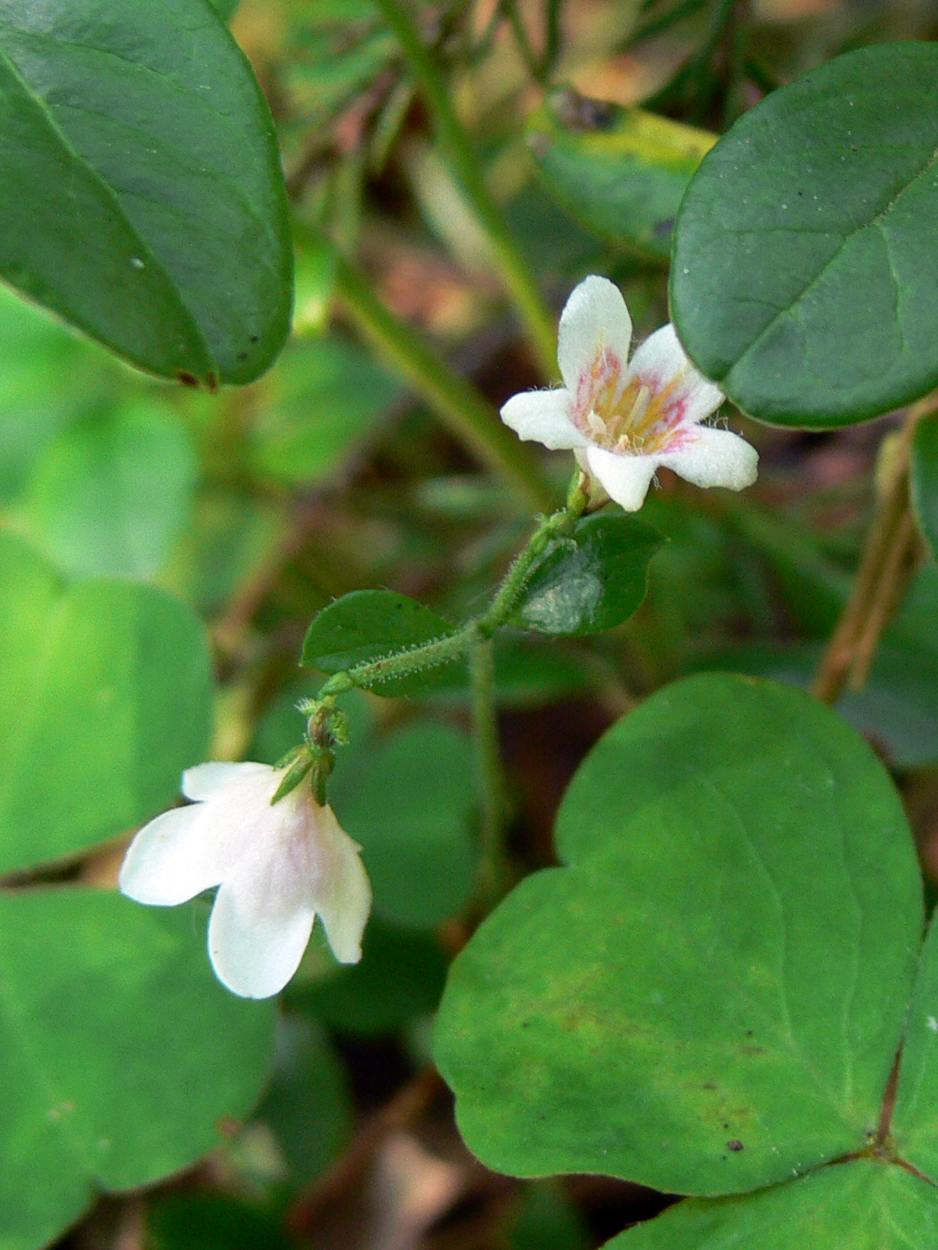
209, 845, 315, 999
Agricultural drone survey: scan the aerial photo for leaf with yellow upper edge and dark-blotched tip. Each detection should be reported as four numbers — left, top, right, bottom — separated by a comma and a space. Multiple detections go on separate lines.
528, 89, 717, 263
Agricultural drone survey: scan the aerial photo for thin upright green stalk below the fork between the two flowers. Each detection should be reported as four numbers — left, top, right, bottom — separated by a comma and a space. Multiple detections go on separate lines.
469, 639, 508, 906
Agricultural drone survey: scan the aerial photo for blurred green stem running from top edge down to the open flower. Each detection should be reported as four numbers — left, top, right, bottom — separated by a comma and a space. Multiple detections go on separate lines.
378, 0, 557, 378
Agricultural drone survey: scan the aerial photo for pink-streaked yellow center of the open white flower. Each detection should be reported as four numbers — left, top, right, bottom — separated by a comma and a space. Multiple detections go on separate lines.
573, 343, 688, 456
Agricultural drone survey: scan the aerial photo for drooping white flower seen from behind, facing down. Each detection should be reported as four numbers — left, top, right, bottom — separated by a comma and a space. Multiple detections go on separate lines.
119, 764, 371, 999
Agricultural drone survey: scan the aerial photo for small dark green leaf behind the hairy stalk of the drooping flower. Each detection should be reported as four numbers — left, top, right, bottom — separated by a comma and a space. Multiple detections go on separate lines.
300, 590, 465, 699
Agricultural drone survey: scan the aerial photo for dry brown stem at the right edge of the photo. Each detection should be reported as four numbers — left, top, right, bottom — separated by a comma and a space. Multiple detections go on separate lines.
812, 396, 938, 704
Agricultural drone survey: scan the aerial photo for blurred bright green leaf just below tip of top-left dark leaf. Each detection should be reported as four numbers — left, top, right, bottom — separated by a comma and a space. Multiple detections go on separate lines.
253, 339, 401, 485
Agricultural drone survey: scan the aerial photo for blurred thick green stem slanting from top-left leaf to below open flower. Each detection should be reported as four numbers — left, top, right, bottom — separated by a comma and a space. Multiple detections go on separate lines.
335, 256, 553, 508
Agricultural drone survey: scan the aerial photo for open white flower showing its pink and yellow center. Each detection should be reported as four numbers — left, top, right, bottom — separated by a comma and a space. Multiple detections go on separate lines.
502, 276, 758, 513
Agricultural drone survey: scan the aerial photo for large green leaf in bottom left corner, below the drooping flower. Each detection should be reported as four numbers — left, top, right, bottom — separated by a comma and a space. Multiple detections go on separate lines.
0, 889, 274, 1250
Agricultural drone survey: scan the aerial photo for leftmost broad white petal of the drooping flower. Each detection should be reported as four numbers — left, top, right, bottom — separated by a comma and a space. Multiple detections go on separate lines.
118, 806, 230, 908
